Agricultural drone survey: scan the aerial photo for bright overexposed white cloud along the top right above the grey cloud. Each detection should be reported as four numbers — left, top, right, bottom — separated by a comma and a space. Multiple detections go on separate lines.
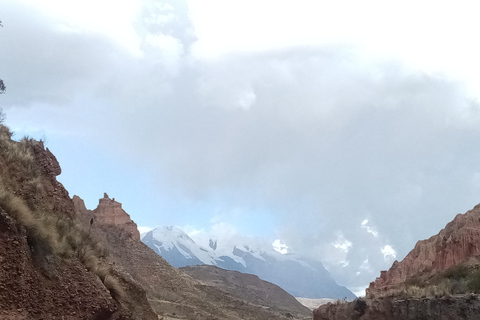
189, 0, 480, 97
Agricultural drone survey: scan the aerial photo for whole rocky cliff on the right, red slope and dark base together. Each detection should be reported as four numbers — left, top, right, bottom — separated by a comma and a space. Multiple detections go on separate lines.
314, 205, 480, 320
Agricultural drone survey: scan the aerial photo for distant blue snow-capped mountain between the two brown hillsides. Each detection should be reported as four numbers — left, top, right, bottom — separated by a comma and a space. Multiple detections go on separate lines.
142, 227, 355, 299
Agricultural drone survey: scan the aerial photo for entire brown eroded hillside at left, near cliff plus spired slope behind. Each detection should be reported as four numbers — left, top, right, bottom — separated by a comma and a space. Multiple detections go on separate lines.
0, 121, 312, 320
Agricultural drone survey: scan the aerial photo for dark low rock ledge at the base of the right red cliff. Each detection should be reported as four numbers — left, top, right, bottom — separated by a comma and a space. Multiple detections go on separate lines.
313, 295, 480, 320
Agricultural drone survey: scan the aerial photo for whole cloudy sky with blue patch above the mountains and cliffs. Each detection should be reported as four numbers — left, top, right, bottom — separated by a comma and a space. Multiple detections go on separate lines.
0, 0, 480, 294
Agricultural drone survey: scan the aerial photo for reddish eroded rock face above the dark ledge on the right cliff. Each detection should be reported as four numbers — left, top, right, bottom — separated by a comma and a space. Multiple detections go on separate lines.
367, 205, 480, 295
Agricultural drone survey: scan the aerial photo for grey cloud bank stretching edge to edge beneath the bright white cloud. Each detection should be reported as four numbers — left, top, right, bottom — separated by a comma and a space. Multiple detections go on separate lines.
0, 1, 480, 287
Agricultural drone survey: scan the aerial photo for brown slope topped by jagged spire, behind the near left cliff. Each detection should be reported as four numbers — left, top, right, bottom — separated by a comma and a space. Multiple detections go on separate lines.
72, 194, 311, 320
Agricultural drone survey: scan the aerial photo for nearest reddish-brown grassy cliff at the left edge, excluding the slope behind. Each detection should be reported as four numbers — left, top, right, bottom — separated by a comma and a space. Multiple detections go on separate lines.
0, 131, 156, 320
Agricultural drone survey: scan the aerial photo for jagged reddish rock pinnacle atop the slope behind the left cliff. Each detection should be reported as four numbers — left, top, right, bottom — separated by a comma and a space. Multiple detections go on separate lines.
93, 193, 140, 241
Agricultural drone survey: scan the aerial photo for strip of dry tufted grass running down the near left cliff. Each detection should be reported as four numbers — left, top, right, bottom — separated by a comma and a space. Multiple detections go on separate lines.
0, 120, 123, 299
